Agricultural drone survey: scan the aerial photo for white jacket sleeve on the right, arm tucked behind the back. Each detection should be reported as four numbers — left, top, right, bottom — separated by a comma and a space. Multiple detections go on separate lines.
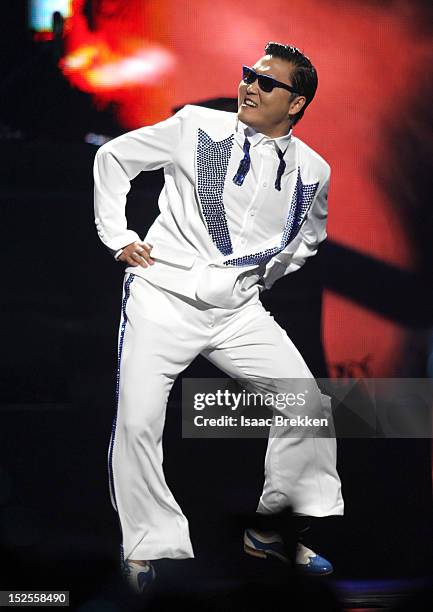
263, 166, 331, 289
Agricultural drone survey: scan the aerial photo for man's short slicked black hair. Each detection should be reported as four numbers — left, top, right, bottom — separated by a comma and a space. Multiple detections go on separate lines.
265, 42, 317, 125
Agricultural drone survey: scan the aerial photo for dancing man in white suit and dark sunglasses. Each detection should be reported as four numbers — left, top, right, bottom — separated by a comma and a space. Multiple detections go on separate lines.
94, 43, 343, 591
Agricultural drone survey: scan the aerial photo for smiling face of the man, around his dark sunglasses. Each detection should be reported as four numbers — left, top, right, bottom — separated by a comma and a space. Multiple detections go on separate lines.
238, 55, 306, 138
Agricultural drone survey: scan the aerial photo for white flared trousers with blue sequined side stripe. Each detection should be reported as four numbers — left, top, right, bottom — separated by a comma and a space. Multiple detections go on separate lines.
108, 273, 344, 560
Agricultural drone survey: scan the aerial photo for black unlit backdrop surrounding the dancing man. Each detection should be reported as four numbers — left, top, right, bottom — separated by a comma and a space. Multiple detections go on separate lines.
0, 3, 432, 608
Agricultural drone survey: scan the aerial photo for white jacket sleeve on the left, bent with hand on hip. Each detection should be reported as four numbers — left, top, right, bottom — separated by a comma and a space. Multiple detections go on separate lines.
93, 105, 190, 255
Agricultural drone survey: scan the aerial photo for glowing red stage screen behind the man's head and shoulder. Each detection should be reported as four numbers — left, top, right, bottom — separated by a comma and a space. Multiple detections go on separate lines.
61, 0, 432, 377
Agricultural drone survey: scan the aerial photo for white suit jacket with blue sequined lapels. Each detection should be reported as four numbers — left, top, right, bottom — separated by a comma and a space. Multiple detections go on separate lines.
94, 105, 330, 308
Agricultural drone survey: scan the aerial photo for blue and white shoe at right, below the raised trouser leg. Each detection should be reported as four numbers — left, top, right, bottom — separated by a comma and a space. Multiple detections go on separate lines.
244, 529, 334, 576
